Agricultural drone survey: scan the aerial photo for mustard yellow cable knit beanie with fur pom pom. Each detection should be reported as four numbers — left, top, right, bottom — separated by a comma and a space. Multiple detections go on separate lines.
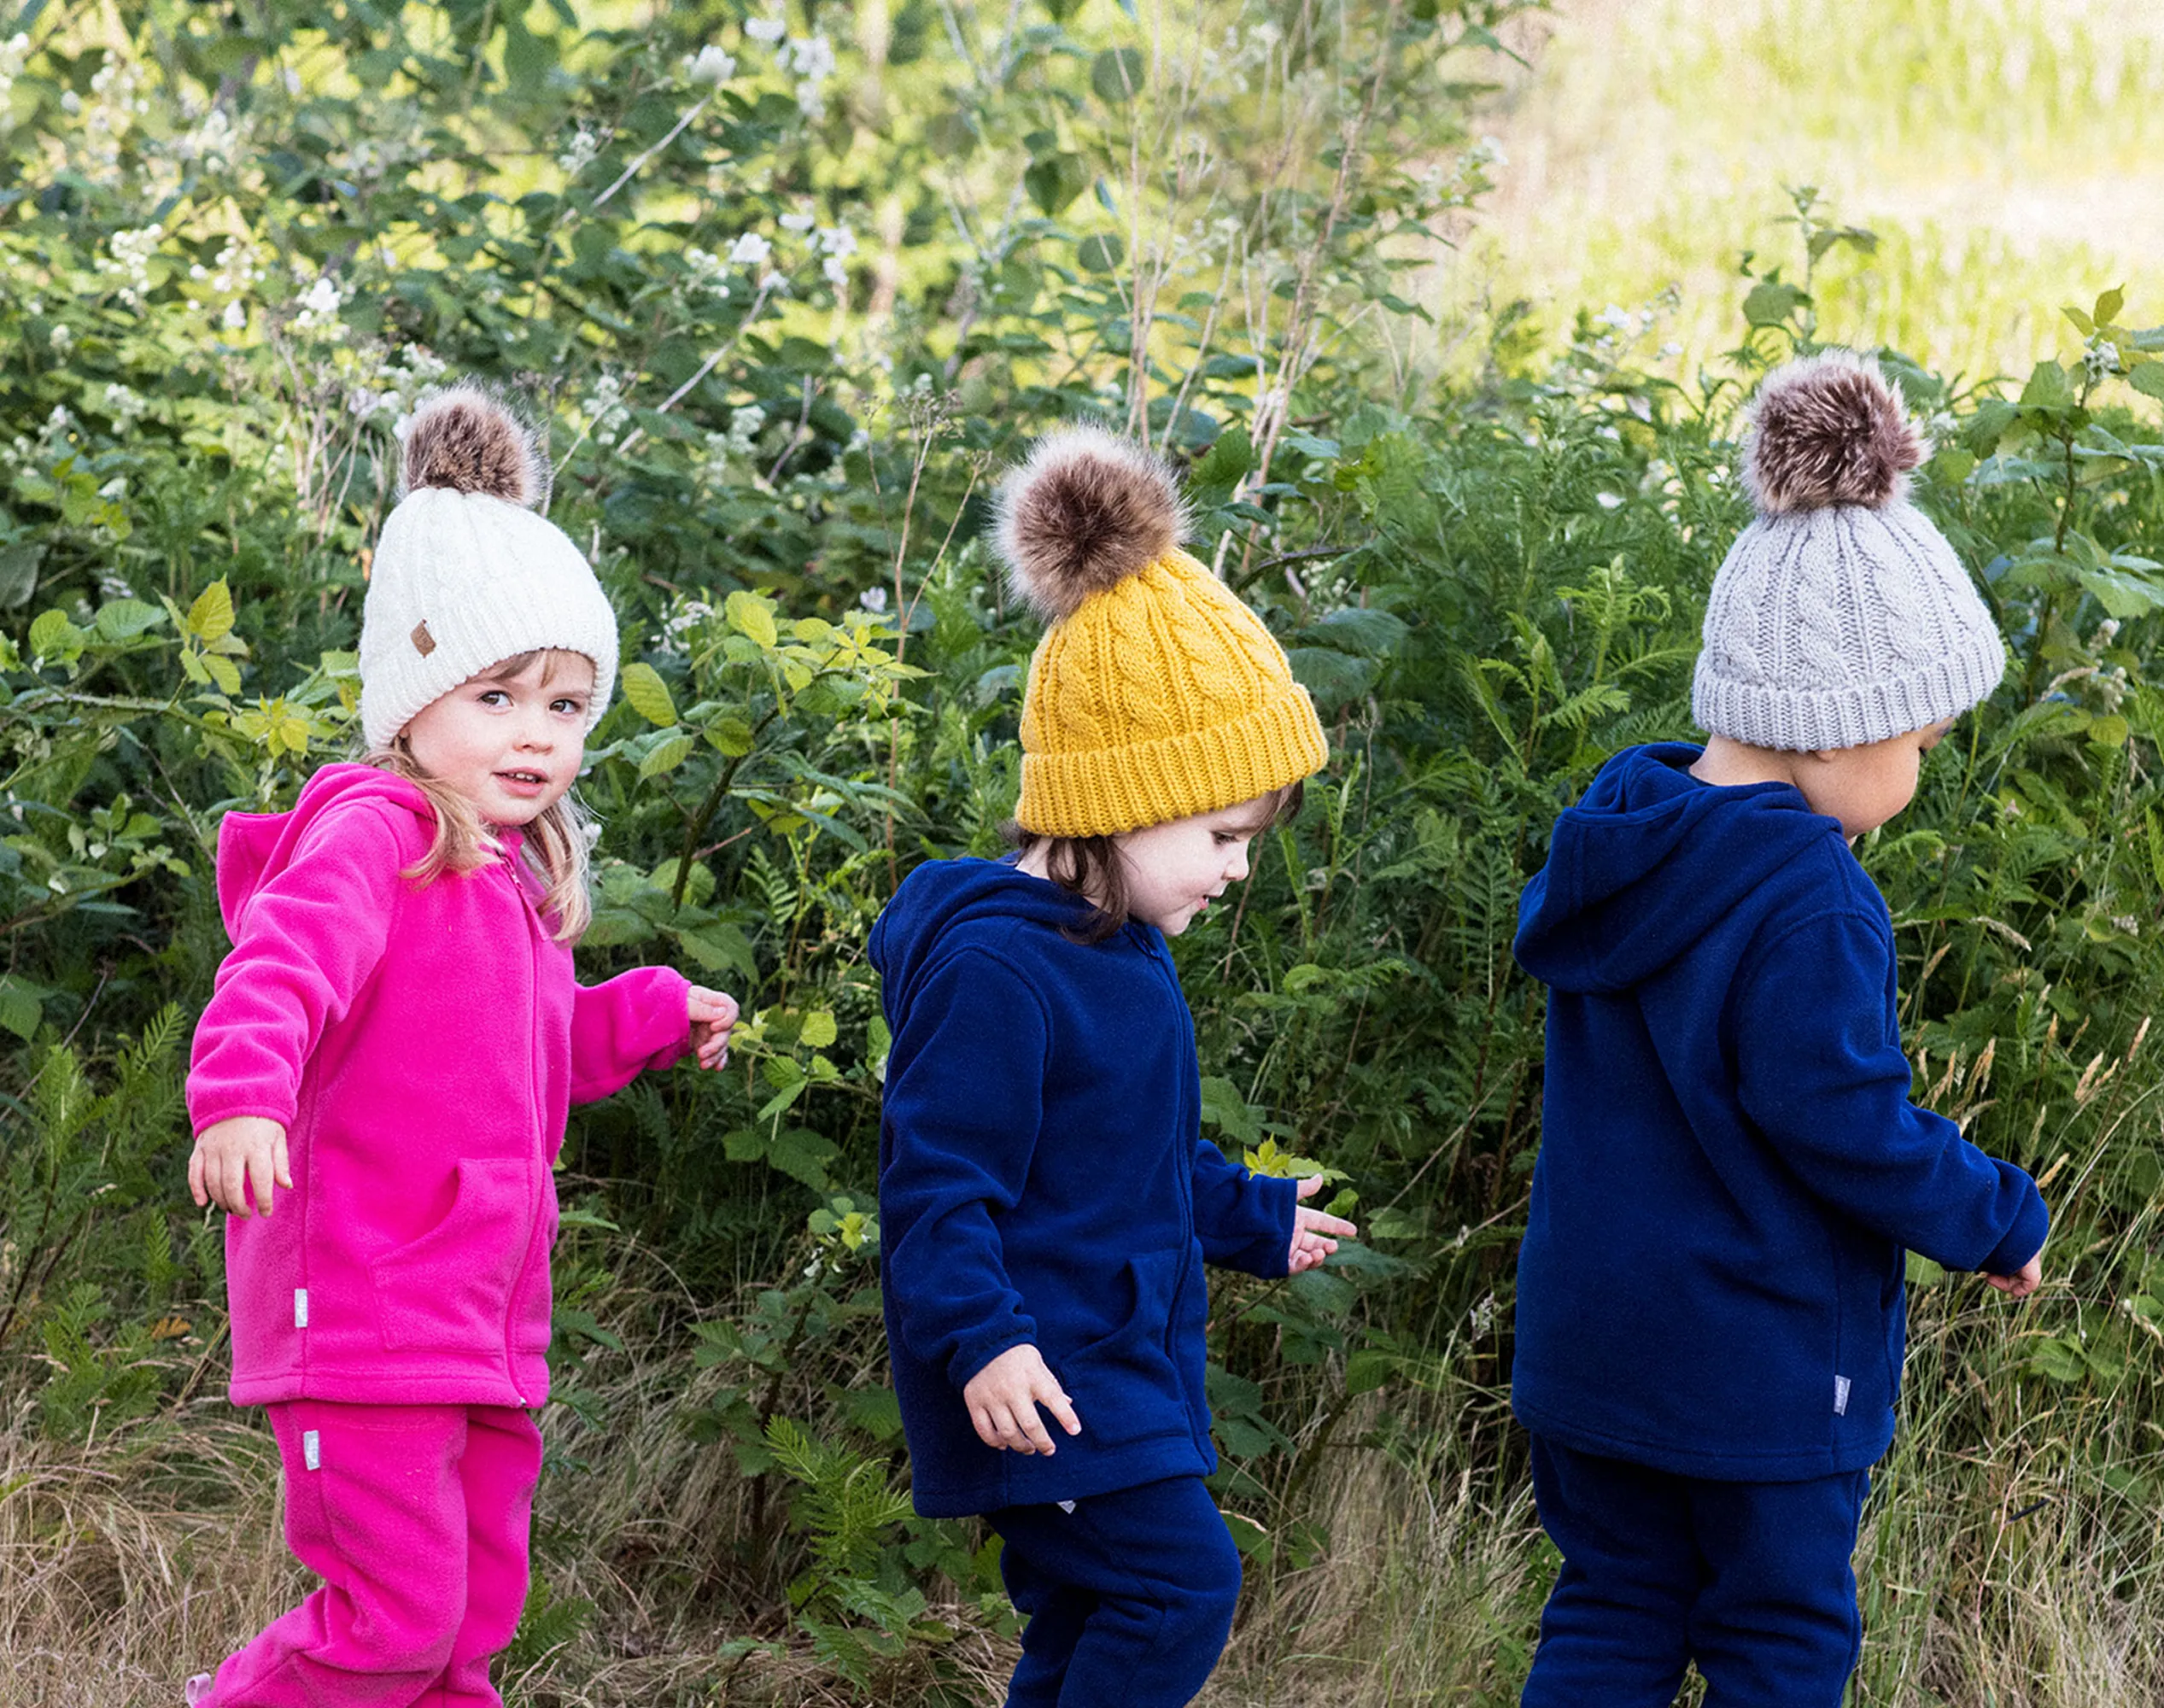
996, 426, 1329, 835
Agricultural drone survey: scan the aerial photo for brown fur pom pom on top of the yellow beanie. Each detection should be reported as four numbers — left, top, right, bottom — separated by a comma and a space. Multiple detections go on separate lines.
993, 426, 1188, 619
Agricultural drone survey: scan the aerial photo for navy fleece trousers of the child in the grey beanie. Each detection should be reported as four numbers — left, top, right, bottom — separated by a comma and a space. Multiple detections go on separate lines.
1521, 1436, 1869, 1708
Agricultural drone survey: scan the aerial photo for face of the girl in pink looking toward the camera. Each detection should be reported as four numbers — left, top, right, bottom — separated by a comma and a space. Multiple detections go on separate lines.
405, 652, 593, 827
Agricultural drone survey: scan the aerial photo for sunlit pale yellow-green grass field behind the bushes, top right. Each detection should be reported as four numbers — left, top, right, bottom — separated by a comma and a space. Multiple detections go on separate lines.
1437, 0, 2164, 377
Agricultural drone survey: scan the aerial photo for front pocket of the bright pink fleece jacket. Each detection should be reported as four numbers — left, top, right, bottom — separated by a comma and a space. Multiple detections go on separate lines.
370, 1156, 536, 1351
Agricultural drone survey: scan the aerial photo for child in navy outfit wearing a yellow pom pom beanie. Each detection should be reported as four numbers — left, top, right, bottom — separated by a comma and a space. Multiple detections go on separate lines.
872, 429, 1354, 1708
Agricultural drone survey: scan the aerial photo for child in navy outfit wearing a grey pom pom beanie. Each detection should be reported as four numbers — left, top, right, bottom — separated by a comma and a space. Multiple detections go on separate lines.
1512, 351, 2047, 1708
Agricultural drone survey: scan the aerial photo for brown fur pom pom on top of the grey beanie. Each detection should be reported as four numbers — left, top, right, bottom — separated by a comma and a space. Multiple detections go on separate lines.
1744, 351, 1930, 515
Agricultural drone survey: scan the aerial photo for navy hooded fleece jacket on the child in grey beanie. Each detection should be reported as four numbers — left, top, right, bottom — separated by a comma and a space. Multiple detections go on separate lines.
1512, 742, 2047, 1483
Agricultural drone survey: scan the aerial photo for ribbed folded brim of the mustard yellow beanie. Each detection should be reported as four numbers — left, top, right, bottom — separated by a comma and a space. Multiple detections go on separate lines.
1015, 681, 1329, 835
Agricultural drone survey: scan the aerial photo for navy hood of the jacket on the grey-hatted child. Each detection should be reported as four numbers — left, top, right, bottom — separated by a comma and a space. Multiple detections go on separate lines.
1517, 742, 1846, 993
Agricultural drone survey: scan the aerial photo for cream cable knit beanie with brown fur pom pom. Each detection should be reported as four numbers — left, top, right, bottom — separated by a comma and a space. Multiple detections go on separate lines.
361, 385, 617, 747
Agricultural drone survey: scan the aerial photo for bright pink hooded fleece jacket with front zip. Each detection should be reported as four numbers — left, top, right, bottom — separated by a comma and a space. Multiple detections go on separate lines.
188, 764, 690, 1405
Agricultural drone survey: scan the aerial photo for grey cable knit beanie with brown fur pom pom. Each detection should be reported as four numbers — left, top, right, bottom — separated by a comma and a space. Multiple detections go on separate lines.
1690, 351, 2006, 752
